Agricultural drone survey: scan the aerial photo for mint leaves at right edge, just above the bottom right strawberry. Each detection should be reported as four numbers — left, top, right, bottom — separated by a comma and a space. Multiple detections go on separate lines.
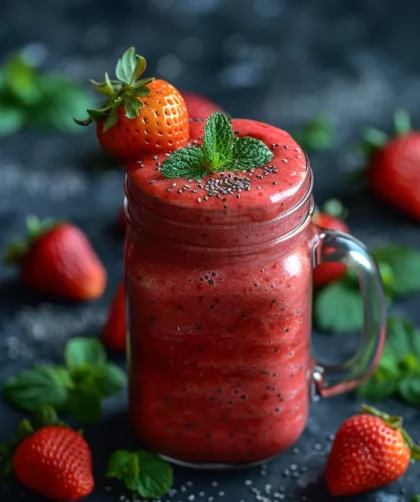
358, 317, 420, 406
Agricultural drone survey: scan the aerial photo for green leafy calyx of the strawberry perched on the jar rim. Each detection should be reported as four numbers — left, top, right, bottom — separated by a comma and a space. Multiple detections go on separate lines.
74, 47, 155, 132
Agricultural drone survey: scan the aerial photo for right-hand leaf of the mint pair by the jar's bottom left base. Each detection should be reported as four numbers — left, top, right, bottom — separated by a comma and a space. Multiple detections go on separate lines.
136, 450, 173, 498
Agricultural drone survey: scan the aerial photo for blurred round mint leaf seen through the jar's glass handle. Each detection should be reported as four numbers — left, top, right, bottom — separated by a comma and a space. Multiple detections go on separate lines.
314, 282, 363, 333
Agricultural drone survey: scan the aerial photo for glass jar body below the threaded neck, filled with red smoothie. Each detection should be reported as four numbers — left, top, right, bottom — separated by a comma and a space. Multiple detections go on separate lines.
125, 210, 314, 465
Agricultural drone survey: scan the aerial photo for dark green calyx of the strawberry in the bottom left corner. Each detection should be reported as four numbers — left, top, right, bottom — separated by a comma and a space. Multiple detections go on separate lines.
0, 406, 69, 479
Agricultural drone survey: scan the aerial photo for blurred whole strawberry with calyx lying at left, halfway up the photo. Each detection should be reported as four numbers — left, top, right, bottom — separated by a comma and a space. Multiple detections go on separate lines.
6, 217, 107, 301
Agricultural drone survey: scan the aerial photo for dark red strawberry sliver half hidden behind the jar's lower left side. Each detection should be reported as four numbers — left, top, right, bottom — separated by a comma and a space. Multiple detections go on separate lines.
102, 281, 126, 352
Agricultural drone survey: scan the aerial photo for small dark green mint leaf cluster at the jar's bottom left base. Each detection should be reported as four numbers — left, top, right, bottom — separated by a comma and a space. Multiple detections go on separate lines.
107, 450, 173, 499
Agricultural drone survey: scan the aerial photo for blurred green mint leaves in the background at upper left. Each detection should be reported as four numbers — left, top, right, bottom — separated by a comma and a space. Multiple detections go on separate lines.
0, 53, 92, 137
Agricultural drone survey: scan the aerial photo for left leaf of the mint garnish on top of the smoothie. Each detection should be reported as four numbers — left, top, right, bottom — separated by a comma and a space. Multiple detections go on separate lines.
161, 147, 207, 179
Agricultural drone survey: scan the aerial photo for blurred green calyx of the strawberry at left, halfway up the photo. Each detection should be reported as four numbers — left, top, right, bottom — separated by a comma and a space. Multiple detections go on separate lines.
5, 216, 63, 264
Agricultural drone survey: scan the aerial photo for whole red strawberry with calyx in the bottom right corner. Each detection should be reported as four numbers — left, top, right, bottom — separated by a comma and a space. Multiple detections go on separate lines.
325, 406, 420, 496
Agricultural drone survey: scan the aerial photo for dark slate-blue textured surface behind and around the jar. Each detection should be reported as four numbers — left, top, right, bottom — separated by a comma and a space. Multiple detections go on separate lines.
0, 0, 420, 502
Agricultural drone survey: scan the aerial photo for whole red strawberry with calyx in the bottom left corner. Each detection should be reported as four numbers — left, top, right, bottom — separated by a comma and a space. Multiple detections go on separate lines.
1, 407, 94, 502
